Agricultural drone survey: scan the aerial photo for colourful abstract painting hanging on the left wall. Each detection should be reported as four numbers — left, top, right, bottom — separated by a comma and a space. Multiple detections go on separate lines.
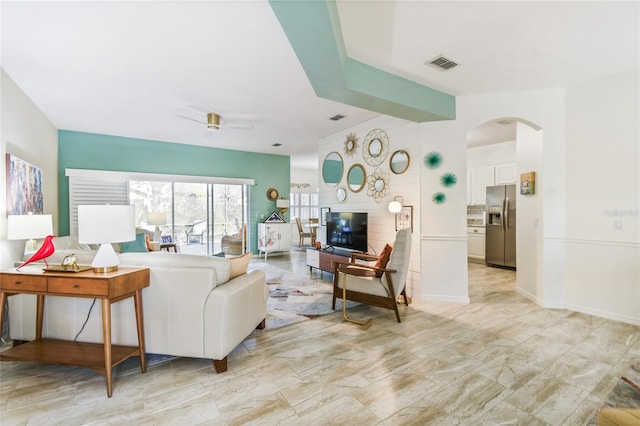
6, 154, 44, 214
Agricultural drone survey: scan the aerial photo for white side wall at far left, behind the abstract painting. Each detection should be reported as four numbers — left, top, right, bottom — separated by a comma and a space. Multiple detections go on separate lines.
0, 69, 58, 267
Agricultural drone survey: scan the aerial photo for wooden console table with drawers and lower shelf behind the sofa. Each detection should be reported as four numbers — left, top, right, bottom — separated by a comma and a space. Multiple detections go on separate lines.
0, 267, 149, 397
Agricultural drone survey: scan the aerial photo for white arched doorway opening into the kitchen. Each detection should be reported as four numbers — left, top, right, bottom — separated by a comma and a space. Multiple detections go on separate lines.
467, 117, 543, 301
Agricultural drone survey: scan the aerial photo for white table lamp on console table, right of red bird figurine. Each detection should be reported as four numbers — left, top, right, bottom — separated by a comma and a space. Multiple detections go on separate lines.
78, 205, 136, 272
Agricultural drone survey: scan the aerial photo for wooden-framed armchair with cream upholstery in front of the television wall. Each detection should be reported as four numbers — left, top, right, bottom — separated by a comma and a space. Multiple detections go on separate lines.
332, 229, 411, 322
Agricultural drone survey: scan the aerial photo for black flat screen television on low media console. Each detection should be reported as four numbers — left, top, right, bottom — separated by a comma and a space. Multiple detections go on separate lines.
326, 212, 369, 253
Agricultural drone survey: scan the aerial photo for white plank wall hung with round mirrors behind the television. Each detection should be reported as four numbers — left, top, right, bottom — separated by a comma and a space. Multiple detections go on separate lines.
318, 116, 421, 297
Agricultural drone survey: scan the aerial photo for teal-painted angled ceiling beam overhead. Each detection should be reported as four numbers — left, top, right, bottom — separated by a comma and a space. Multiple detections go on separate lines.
269, 0, 456, 122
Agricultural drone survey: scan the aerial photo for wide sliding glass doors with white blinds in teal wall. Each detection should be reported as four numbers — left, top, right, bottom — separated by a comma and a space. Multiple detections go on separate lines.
65, 169, 254, 254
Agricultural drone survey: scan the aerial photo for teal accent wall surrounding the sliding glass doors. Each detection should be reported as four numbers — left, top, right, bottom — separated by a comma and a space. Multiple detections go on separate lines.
58, 130, 291, 253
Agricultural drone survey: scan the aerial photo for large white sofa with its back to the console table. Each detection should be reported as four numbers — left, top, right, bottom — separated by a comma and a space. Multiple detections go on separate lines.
9, 237, 269, 373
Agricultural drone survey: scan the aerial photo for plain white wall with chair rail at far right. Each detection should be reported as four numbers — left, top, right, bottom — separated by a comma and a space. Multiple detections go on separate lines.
565, 69, 640, 325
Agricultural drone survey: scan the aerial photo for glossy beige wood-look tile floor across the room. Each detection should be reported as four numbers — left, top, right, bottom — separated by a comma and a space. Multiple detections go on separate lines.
0, 251, 640, 426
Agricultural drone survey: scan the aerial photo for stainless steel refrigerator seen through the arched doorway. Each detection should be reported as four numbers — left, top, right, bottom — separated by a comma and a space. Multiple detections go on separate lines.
485, 185, 516, 269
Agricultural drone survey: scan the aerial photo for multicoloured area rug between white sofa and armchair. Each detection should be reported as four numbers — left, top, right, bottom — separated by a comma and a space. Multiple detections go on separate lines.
249, 262, 359, 329
